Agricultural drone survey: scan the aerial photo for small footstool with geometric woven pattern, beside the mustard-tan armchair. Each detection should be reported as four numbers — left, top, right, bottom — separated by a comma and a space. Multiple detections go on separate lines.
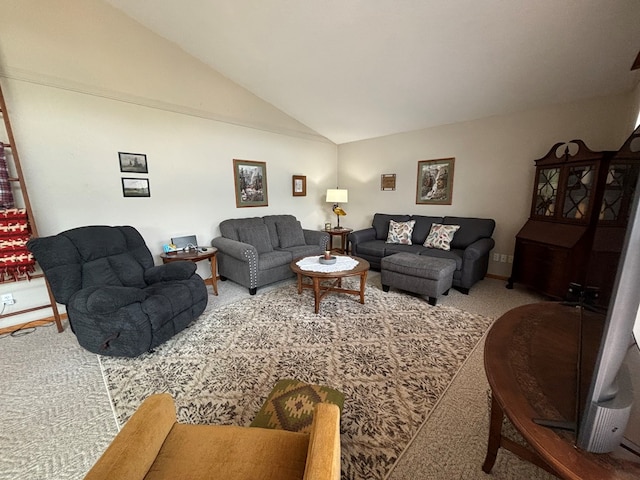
251, 379, 344, 433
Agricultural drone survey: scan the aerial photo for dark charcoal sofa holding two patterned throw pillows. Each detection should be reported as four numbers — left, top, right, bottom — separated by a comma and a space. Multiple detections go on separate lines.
349, 213, 496, 294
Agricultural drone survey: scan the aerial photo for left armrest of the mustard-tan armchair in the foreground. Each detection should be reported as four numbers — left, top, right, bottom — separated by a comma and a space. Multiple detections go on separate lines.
84, 393, 176, 480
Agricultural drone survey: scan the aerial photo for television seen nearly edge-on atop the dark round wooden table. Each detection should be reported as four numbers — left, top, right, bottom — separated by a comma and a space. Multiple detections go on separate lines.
576, 127, 640, 462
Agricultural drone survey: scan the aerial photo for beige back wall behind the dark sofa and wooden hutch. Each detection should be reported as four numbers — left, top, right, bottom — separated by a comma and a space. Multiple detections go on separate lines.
338, 94, 637, 276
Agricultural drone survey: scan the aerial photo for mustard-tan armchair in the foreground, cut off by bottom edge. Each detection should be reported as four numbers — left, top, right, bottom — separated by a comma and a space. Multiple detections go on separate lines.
85, 393, 340, 480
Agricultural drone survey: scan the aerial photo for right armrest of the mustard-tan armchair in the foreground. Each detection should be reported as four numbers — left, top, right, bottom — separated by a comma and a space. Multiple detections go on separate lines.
303, 403, 340, 480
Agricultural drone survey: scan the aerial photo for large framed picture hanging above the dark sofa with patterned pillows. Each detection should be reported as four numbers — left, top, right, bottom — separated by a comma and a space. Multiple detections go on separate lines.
416, 158, 455, 205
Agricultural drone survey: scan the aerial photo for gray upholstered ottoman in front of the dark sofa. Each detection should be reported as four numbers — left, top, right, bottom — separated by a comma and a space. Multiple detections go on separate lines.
380, 253, 456, 305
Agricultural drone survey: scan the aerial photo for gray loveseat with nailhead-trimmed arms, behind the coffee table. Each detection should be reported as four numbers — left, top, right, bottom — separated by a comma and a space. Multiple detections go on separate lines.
211, 215, 329, 295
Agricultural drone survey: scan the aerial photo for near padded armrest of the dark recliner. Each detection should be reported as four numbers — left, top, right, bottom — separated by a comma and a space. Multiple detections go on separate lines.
69, 285, 147, 315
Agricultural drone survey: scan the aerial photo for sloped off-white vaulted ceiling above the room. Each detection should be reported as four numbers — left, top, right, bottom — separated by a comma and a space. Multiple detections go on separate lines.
106, 0, 640, 144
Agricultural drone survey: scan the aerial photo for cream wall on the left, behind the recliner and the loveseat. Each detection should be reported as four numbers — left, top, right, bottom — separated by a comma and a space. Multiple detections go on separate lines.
0, 0, 337, 328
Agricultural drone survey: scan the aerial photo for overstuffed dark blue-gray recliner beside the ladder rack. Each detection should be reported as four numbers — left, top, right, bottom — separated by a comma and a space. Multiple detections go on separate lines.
27, 226, 208, 357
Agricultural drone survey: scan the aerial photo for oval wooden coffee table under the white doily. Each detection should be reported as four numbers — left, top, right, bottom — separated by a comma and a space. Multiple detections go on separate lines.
291, 255, 369, 313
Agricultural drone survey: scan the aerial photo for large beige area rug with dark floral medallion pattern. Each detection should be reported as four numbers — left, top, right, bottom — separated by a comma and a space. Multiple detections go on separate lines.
100, 281, 492, 480
